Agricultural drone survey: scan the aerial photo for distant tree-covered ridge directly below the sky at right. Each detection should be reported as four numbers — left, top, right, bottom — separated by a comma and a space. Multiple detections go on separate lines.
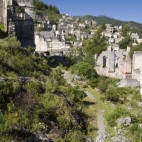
77, 15, 142, 37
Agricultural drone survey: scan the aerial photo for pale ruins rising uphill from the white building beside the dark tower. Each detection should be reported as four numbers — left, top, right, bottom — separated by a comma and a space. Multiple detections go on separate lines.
35, 15, 96, 55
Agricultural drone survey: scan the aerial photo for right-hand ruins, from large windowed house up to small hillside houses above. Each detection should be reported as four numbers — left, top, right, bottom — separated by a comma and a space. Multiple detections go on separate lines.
95, 24, 142, 93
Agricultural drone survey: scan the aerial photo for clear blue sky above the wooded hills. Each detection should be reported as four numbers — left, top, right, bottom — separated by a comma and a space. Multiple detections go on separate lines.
43, 0, 142, 23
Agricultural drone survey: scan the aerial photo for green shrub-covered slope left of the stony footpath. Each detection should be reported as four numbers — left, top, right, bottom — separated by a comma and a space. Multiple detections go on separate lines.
0, 38, 96, 142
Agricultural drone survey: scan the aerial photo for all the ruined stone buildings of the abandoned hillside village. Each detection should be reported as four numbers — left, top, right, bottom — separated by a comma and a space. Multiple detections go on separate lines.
0, 0, 142, 93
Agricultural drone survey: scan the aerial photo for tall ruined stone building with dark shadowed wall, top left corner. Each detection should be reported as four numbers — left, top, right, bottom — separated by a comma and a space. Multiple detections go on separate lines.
3, 0, 34, 47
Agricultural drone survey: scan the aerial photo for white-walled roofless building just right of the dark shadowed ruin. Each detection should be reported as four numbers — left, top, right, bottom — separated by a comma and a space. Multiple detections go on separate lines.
35, 31, 70, 55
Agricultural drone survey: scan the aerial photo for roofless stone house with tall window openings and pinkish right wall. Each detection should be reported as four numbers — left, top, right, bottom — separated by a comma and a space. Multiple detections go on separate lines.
95, 51, 131, 79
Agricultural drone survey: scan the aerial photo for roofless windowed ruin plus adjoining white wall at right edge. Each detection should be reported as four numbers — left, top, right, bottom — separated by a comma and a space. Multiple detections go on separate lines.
95, 50, 142, 94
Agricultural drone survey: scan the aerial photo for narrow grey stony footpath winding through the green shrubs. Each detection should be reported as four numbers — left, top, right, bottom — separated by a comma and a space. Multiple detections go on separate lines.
63, 71, 106, 142
